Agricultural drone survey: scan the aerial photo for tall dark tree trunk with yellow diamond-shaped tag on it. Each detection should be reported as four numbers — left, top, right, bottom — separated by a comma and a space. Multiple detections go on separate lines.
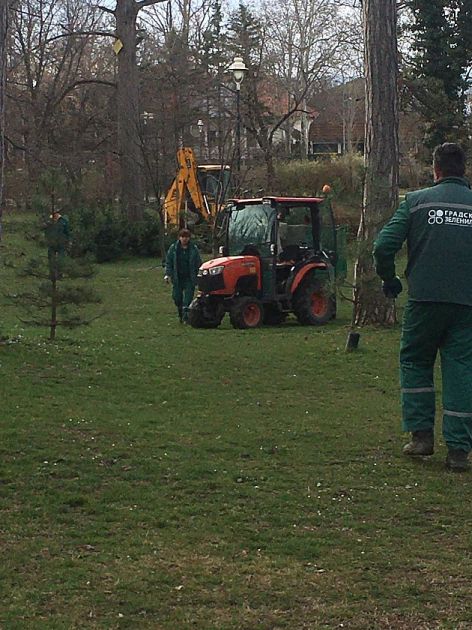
115, 0, 144, 221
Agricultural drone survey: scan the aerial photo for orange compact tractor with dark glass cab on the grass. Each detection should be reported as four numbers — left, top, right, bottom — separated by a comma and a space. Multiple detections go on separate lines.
189, 197, 346, 328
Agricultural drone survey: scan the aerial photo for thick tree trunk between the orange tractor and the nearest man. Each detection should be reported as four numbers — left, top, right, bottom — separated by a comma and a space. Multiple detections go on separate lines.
353, 0, 399, 325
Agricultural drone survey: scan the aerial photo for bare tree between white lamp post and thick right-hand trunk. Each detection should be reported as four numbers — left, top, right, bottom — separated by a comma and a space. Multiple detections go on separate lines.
230, 0, 342, 189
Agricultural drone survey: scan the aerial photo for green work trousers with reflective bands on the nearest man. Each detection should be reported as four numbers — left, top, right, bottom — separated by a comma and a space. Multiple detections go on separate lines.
400, 300, 472, 453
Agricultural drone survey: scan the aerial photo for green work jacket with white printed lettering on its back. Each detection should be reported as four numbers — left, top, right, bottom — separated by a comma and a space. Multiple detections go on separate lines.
374, 177, 472, 306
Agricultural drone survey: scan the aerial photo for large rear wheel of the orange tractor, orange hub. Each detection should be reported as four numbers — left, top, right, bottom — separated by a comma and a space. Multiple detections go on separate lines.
293, 277, 336, 326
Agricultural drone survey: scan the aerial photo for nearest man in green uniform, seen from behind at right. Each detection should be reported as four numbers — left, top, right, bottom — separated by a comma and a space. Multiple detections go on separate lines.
374, 143, 472, 472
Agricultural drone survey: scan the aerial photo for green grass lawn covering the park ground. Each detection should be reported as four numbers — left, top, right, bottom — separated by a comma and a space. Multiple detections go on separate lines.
0, 219, 472, 630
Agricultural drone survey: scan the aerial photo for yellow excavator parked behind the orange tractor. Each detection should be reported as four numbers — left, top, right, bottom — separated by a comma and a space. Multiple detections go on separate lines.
164, 147, 230, 228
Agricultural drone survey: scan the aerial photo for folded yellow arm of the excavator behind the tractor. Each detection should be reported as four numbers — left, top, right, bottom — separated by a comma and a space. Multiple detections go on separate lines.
164, 147, 211, 226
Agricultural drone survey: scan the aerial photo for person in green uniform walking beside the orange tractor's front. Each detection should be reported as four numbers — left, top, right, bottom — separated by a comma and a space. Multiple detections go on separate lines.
164, 228, 202, 322
